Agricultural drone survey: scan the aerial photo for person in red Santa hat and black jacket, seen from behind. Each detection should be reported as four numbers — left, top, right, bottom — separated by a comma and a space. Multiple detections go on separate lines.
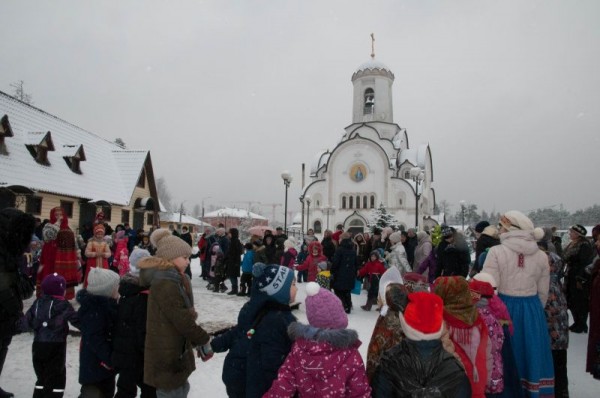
372, 292, 474, 398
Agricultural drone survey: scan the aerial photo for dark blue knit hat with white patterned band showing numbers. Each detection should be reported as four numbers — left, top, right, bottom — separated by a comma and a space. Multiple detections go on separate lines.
252, 263, 294, 304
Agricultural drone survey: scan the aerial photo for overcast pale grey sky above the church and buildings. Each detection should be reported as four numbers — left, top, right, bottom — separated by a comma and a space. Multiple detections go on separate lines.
0, 0, 600, 216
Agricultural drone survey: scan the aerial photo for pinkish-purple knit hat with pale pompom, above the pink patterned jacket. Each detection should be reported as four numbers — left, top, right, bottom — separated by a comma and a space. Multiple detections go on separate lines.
306, 282, 348, 329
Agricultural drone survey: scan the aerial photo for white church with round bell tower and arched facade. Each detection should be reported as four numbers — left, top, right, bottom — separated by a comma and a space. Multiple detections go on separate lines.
300, 54, 437, 234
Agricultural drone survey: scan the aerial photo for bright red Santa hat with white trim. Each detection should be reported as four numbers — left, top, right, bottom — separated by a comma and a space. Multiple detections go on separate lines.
398, 292, 444, 341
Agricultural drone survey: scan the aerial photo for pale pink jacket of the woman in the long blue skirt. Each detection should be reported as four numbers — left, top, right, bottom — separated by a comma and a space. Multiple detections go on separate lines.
482, 231, 550, 307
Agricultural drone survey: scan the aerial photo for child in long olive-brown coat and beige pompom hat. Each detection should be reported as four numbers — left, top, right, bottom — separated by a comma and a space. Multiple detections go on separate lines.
138, 228, 212, 397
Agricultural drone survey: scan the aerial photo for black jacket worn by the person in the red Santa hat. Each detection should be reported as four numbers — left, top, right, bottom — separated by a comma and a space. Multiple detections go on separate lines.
371, 339, 471, 398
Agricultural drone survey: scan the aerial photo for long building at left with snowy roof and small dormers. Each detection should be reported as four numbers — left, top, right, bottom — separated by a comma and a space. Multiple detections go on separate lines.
0, 92, 159, 230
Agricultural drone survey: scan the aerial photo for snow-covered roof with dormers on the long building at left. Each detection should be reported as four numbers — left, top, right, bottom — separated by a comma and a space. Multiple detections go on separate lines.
0, 91, 149, 206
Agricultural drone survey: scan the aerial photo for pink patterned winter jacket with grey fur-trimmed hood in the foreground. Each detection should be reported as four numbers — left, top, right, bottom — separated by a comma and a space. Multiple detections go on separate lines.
263, 322, 371, 398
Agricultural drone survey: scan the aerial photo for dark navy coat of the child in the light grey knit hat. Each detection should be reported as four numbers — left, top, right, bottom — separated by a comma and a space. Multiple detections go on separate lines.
77, 289, 117, 384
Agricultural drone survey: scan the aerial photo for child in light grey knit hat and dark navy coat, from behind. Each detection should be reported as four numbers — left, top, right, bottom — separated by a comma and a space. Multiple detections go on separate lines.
77, 268, 119, 398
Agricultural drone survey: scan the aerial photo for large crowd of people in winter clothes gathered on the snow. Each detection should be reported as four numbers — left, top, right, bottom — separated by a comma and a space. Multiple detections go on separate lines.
0, 208, 600, 398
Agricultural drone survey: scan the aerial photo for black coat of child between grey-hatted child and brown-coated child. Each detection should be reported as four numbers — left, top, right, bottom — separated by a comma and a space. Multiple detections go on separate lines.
112, 274, 149, 376
